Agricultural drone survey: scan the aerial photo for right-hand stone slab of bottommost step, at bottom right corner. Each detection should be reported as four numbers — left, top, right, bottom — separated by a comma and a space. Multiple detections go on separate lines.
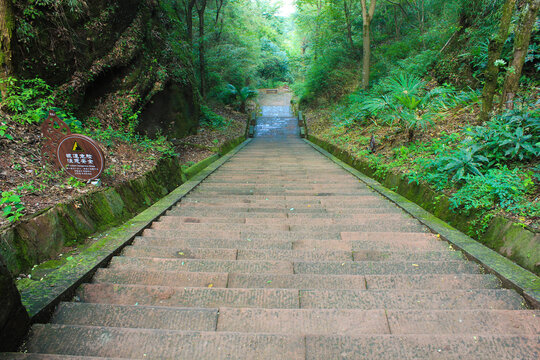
306, 334, 540, 360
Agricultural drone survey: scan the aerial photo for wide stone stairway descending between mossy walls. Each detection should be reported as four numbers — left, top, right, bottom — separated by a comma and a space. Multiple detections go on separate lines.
3, 102, 540, 360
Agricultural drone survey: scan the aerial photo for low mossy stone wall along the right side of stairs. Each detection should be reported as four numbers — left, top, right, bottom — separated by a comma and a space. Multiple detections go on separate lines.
308, 135, 540, 274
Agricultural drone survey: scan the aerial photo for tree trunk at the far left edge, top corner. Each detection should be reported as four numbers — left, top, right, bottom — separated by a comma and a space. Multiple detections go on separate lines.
0, 0, 15, 97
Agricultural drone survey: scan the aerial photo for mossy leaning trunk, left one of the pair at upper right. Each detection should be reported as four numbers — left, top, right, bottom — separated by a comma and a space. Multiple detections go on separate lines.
480, 0, 516, 122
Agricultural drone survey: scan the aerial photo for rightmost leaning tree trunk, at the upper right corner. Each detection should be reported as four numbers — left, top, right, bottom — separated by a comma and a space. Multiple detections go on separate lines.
500, 0, 540, 109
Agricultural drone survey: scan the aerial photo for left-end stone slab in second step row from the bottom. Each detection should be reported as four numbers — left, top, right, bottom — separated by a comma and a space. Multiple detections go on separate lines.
51, 302, 218, 331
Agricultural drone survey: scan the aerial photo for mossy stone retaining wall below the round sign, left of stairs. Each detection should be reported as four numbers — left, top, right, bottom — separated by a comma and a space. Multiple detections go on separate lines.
0, 159, 183, 275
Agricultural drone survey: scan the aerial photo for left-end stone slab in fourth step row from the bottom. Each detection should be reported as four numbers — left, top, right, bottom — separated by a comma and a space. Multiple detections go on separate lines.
92, 268, 228, 288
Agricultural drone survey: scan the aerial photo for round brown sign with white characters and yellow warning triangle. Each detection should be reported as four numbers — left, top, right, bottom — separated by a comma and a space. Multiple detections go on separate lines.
56, 134, 105, 181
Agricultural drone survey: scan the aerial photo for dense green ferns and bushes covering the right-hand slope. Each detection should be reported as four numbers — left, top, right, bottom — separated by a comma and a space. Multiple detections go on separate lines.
294, 0, 540, 233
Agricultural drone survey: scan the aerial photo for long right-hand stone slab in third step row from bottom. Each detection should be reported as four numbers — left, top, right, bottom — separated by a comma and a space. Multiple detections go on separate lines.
300, 286, 525, 310
